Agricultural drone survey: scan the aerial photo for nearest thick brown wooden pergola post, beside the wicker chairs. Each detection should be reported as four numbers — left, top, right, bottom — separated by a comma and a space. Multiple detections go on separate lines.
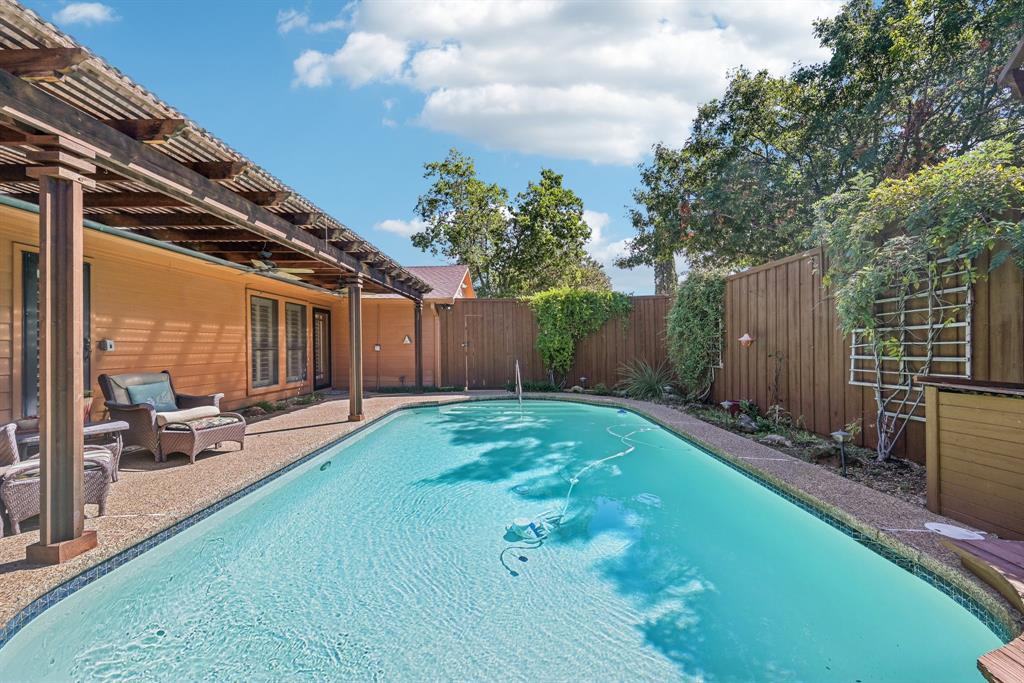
26, 138, 96, 564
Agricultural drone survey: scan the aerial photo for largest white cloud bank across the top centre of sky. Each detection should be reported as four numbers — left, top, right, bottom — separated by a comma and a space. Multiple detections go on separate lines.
282, 0, 840, 164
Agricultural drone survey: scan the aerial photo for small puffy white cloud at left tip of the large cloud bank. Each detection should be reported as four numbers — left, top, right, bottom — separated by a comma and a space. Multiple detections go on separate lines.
294, 32, 406, 88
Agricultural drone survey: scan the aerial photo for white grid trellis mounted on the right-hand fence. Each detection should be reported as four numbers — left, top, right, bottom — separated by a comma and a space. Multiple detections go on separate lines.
850, 259, 974, 422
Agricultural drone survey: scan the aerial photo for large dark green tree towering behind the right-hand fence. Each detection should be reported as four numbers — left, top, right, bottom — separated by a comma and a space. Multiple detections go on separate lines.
622, 0, 1024, 268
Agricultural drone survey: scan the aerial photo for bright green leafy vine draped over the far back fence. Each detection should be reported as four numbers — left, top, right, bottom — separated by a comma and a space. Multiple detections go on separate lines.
524, 287, 633, 376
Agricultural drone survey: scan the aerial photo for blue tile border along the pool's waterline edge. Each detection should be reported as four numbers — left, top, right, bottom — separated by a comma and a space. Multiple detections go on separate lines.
0, 396, 1015, 647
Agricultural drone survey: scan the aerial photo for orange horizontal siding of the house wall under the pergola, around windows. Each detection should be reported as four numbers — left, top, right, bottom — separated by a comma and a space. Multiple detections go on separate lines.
0, 201, 352, 421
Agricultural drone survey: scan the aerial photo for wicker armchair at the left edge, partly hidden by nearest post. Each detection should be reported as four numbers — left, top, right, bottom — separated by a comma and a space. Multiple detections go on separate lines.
0, 424, 115, 536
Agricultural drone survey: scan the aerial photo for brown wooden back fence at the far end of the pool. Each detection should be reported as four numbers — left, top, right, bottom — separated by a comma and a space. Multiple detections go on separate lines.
439, 296, 672, 389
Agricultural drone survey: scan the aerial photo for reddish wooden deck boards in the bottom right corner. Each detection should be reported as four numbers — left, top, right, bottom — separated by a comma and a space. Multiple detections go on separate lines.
942, 539, 1024, 683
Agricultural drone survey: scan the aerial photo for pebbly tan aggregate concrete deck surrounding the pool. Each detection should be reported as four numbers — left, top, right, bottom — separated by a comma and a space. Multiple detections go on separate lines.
0, 391, 1020, 643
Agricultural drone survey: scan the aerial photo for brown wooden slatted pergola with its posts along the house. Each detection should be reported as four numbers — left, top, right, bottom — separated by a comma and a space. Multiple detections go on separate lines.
0, 0, 430, 563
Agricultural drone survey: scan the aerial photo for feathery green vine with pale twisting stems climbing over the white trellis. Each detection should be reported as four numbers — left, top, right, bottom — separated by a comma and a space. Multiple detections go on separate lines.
815, 141, 1024, 460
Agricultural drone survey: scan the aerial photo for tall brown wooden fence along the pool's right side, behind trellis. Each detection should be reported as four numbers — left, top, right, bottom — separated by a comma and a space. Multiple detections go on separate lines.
712, 249, 1024, 462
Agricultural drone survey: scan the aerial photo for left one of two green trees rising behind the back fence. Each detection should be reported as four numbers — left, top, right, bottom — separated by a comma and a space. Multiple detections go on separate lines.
413, 148, 508, 296
